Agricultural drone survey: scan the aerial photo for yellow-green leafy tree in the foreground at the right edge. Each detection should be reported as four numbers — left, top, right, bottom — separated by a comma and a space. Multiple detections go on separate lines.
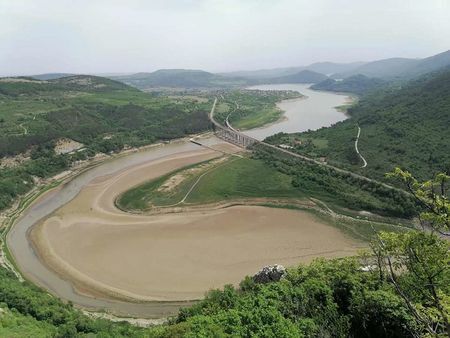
372, 168, 450, 337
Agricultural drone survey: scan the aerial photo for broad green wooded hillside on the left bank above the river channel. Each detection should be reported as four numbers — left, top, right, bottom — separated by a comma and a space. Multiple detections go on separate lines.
0, 76, 212, 210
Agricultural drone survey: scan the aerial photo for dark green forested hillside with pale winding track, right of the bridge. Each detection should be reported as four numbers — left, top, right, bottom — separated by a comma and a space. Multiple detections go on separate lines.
269, 69, 450, 179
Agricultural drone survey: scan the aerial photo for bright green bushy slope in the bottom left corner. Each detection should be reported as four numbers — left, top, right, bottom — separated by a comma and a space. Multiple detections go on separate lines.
0, 268, 162, 337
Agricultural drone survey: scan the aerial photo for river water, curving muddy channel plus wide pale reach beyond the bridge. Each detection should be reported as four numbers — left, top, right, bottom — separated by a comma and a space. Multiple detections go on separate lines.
7, 84, 346, 318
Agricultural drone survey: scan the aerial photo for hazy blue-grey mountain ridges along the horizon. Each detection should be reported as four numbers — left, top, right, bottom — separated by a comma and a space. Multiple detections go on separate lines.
22, 50, 450, 90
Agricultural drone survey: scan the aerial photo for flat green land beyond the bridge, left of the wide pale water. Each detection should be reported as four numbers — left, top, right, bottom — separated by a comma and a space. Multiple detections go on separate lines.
214, 90, 302, 129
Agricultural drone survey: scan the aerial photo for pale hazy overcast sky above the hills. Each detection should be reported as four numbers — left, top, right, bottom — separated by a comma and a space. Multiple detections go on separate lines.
0, 0, 450, 76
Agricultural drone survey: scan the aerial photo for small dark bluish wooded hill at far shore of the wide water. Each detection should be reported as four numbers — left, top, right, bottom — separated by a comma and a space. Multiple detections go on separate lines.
311, 75, 385, 95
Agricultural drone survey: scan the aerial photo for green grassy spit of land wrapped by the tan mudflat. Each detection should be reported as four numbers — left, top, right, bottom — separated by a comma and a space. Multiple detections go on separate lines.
117, 157, 305, 210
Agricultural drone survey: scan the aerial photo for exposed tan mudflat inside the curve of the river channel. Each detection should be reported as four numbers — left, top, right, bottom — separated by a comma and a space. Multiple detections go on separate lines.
30, 145, 361, 301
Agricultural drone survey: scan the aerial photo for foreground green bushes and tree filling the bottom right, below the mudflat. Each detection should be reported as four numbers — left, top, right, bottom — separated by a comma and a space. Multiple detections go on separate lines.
171, 169, 450, 337
